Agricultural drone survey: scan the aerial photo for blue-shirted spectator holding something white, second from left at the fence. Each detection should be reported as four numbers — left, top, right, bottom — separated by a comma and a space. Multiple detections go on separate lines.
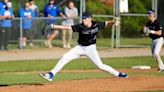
19, 2, 35, 49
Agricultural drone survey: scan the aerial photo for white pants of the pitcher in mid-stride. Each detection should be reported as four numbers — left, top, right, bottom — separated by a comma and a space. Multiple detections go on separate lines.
50, 44, 119, 76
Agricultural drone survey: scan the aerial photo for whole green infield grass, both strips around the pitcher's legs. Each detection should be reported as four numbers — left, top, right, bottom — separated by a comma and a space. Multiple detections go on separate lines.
0, 57, 164, 85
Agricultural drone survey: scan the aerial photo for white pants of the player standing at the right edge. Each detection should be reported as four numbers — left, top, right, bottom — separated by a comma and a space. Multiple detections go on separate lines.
151, 37, 164, 69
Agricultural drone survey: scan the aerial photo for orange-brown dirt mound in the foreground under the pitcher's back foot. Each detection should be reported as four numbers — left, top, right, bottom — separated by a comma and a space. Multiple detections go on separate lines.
0, 76, 164, 92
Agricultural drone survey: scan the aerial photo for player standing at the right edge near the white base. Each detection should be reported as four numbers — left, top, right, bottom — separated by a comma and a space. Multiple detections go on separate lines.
146, 10, 164, 72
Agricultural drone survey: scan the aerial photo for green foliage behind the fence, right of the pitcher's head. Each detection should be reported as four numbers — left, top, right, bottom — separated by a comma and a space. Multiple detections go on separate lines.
86, 0, 151, 38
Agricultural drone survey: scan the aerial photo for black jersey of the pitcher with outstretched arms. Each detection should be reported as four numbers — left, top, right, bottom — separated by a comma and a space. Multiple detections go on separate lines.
72, 21, 105, 46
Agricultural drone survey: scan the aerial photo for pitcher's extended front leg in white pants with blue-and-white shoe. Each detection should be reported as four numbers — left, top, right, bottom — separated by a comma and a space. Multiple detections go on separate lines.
40, 45, 84, 81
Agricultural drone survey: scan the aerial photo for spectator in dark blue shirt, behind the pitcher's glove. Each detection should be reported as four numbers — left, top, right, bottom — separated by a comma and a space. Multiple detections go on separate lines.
44, 0, 65, 48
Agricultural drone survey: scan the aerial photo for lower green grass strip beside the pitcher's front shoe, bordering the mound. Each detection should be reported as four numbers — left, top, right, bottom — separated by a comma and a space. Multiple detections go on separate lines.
0, 72, 111, 85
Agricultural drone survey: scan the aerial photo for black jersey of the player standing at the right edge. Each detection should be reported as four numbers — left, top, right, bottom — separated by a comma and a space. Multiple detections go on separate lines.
146, 20, 162, 40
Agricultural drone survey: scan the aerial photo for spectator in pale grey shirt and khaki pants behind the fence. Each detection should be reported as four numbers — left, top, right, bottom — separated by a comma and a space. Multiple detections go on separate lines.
62, 2, 78, 48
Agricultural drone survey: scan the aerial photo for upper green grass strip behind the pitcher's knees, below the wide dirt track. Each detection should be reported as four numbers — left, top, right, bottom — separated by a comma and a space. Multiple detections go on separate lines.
0, 56, 160, 72
